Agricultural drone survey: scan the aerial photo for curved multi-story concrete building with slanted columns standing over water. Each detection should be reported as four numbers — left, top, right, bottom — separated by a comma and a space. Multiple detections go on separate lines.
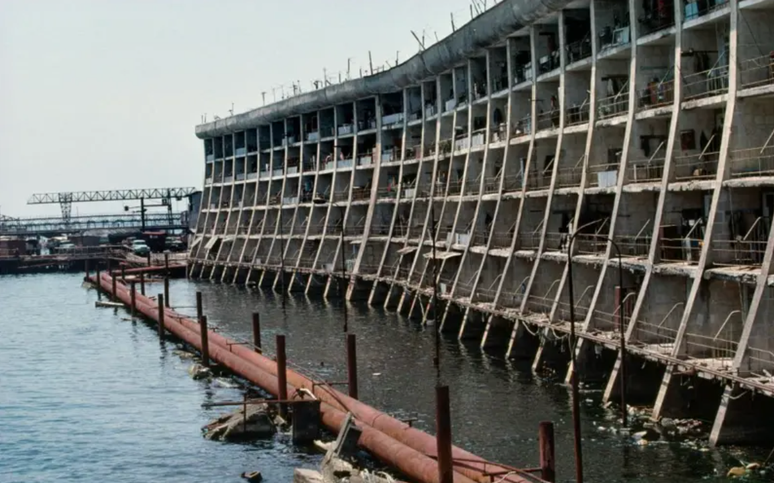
190, 0, 774, 443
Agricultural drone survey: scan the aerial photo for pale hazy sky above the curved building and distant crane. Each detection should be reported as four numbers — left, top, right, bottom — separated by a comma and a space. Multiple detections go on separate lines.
0, 0, 478, 216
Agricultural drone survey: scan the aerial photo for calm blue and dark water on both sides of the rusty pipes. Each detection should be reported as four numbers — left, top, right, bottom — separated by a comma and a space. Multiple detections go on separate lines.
0, 275, 768, 483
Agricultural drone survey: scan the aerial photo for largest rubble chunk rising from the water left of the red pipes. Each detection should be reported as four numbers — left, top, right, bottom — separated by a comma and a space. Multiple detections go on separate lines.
202, 404, 275, 441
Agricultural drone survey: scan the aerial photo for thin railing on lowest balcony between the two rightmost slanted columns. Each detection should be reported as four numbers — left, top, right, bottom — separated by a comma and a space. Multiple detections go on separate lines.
684, 310, 744, 369
